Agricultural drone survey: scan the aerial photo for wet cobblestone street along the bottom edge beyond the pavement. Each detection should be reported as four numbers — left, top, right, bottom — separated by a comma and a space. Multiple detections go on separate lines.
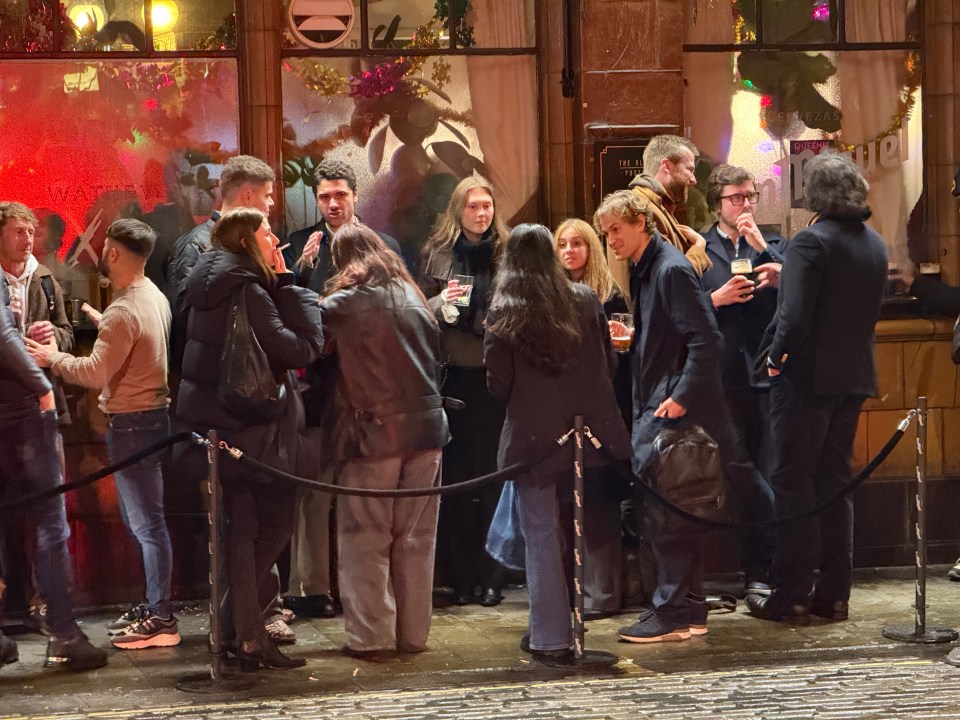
2, 660, 960, 720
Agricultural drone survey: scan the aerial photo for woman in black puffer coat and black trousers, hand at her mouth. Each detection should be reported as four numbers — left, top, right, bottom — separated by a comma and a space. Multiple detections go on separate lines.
177, 208, 323, 672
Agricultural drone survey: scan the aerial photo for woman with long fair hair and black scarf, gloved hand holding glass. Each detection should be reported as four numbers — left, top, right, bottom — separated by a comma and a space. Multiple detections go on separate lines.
419, 177, 507, 606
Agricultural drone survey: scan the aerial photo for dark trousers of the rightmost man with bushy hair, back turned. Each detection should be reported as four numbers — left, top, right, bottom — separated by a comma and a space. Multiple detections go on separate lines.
770, 375, 864, 605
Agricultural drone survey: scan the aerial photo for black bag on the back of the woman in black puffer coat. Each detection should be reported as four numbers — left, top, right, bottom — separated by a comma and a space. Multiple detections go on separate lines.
217, 287, 287, 421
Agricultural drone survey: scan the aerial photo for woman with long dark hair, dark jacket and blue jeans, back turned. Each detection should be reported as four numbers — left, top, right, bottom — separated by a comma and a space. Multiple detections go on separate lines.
484, 225, 629, 665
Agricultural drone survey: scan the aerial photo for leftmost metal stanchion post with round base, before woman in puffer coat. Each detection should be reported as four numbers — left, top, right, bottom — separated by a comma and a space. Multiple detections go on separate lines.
177, 430, 254, 693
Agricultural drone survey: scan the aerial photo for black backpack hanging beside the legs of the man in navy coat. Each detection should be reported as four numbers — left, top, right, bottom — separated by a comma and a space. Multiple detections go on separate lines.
643, 425, 727, 535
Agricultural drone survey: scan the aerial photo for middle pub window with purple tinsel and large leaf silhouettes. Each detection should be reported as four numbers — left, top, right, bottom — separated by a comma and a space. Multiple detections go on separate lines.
282, 0, 540, 261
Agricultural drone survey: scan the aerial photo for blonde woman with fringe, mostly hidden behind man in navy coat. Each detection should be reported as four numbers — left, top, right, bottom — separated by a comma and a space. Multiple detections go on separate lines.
553, 218, 631, 620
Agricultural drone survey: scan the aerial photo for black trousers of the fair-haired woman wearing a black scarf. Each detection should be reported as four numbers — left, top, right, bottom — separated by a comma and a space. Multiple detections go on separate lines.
437, 366, 505, 593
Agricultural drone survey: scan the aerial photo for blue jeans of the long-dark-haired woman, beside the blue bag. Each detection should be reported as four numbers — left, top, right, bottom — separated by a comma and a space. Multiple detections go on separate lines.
516, 472, 573, 650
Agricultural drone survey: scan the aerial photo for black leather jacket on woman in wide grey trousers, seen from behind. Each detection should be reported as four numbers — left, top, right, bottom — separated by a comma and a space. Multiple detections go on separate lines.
320, 280, 450, 460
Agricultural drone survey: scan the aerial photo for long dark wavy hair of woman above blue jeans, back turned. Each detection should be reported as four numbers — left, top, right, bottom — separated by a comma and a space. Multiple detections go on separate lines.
488, 224, 580, 375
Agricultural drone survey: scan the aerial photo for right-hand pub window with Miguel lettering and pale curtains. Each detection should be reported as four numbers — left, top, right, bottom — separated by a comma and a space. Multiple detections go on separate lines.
684, 0, 924, 286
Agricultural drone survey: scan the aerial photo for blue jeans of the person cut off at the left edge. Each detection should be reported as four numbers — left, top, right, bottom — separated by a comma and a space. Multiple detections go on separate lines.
0, 407, 79, 638
